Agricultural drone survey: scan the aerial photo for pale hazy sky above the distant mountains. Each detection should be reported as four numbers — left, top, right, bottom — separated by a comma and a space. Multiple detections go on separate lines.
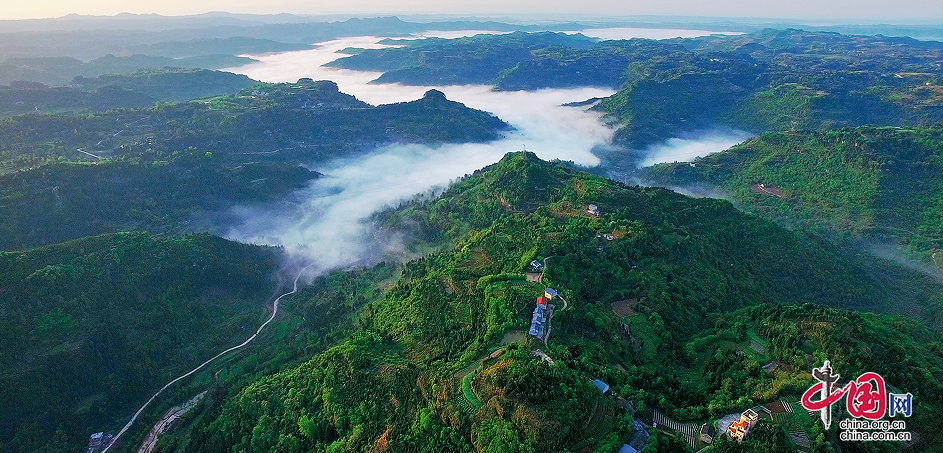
0, 0, 943, 21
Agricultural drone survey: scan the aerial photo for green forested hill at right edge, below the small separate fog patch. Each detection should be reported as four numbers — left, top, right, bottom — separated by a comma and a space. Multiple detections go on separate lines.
641, 127, 943, 267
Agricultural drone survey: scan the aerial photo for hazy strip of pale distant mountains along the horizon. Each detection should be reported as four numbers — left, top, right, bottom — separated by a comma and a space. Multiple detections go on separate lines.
0, 10, 943, 43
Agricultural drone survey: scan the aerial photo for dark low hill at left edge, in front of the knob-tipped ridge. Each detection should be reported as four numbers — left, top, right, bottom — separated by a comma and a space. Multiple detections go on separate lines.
0, 154, 320, 250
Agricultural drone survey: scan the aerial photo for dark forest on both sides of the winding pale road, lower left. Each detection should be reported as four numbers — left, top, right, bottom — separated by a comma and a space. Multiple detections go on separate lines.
0, 233, 410, 453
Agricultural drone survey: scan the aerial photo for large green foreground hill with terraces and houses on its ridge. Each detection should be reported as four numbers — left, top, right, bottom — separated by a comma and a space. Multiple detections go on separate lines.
177, 153, 943, 453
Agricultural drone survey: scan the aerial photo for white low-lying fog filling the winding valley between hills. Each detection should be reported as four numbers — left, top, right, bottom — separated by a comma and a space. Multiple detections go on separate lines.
221, 32, 745, 271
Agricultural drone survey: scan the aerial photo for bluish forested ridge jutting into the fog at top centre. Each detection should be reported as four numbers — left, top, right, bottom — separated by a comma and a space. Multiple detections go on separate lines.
328, 32, 660, 90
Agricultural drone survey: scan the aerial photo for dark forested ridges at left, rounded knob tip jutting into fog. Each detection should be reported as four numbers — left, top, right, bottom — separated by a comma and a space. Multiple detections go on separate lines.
0, 79, 509, 250
